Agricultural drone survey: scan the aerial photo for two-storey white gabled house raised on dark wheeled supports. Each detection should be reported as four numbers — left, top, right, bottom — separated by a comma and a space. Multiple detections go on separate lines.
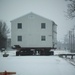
11, 13, 57, 48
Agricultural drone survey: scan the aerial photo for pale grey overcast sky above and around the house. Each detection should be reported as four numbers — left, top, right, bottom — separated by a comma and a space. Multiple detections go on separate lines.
0, 0, 75, 41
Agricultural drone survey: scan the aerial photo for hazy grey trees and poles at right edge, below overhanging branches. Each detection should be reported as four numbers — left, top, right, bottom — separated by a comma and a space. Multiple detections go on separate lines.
64, 26, 75, 52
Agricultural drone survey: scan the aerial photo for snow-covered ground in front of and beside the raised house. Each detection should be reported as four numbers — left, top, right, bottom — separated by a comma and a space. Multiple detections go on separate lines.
0, 50, 75, 75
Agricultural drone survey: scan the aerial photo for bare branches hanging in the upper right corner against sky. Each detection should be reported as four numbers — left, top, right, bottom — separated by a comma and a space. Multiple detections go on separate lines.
65, 0, 75, 18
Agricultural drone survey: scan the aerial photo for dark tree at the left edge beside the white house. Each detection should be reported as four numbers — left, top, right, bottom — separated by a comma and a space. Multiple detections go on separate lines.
0, 21, 9, 48
